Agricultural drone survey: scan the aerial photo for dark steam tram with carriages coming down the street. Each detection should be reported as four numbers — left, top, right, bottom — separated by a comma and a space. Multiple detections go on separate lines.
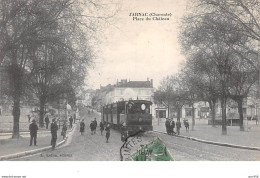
101, 100, 153, 135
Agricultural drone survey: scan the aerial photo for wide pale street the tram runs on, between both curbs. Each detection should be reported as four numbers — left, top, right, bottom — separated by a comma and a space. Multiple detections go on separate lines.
16, 108, 260, 161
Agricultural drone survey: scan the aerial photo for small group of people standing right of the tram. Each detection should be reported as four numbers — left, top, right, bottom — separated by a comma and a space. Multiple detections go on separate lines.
165, 118, 189, 135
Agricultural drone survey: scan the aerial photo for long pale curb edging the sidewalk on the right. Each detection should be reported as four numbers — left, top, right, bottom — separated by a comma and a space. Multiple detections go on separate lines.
153, 130, 260, 151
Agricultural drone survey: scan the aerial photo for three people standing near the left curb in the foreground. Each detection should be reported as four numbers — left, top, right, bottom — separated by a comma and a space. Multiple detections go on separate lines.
29, 119, 60, 149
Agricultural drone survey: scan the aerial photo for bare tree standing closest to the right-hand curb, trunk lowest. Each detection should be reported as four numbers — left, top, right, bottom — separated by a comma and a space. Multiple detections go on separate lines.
181, 1, 260, 134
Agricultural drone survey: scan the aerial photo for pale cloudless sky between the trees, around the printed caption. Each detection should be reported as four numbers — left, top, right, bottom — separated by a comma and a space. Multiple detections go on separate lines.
86, 0, 186, 89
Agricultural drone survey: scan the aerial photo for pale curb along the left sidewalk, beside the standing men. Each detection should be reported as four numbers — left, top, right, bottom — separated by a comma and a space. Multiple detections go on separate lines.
0, 126, 76, 161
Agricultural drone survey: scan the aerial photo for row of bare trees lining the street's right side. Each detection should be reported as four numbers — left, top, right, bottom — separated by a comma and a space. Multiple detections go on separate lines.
155, 0, 260, 134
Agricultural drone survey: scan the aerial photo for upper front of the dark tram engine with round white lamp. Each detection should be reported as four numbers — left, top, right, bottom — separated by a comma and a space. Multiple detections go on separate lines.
128, 103, 150, 114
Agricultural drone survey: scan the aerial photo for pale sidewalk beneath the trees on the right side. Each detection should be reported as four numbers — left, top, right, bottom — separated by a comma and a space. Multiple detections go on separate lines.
153, 119, 260, 148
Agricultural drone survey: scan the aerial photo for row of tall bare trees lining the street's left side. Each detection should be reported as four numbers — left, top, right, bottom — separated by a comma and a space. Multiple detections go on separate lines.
0, 0, 117, 138
